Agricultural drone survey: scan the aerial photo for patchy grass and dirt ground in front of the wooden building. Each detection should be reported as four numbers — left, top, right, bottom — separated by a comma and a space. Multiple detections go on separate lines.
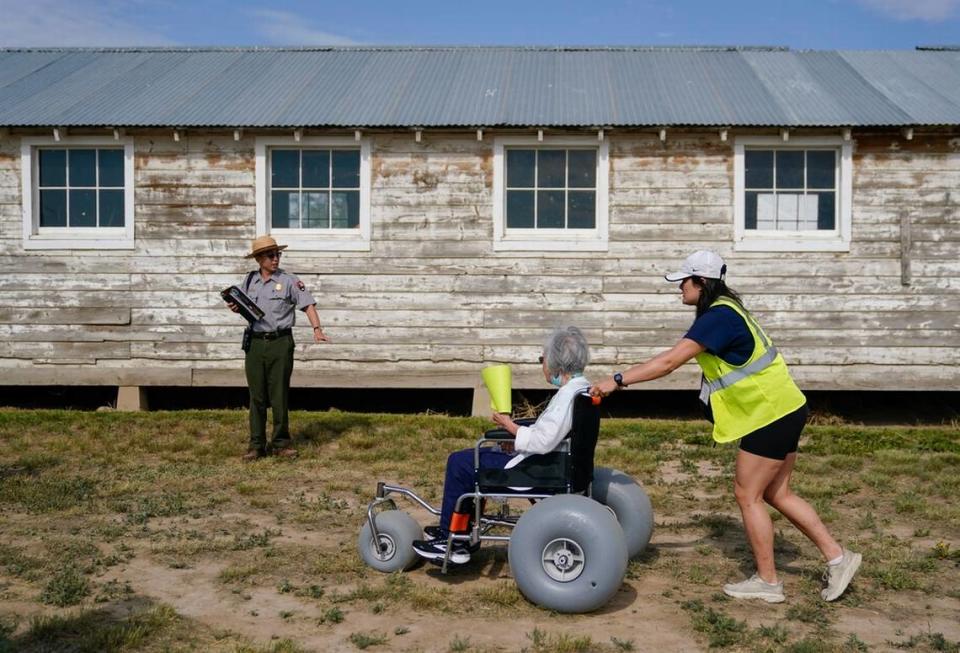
0, 410, 960, 653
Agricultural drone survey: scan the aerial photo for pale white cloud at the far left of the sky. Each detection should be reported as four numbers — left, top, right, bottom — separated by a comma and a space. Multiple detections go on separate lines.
0, 0, 173, 47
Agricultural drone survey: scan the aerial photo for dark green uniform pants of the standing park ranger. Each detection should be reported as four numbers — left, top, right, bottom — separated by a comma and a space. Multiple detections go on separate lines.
244, 335, 293, 452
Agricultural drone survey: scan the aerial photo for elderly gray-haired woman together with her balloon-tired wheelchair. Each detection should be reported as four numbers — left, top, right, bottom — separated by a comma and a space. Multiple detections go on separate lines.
357, 327, 653, 612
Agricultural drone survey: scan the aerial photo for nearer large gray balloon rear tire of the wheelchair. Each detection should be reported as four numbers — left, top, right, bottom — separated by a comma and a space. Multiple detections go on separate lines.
507, 494, 627, 612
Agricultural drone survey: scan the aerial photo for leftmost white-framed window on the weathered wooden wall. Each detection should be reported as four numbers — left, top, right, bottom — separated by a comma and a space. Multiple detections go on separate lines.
21, 137, 134, 249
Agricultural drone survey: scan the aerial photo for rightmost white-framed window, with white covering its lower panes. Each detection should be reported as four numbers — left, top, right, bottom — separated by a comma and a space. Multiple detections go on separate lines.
734, 137, 852, 251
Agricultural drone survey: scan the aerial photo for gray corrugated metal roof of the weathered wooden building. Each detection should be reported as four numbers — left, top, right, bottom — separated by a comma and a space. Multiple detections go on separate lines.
0, 47, 960, 127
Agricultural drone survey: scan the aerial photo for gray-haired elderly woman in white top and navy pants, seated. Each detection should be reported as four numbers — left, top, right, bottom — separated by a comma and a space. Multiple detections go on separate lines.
413, 326, 590, 564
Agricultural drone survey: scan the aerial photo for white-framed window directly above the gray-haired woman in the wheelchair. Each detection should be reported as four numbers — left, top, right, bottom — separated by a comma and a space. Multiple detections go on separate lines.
494, 137, 608, 251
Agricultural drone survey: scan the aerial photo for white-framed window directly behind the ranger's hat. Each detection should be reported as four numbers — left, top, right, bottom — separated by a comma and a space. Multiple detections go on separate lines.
256, 137, 370, 251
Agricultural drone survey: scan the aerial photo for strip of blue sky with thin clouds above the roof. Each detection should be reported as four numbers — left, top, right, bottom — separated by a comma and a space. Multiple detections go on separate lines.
0, 0, 960, 49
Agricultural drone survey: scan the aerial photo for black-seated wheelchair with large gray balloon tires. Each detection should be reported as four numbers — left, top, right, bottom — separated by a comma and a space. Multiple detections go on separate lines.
357, 394, 653, 612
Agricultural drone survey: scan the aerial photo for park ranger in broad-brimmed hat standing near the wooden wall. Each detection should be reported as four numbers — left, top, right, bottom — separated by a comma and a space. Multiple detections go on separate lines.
228, 236, 330, 461
